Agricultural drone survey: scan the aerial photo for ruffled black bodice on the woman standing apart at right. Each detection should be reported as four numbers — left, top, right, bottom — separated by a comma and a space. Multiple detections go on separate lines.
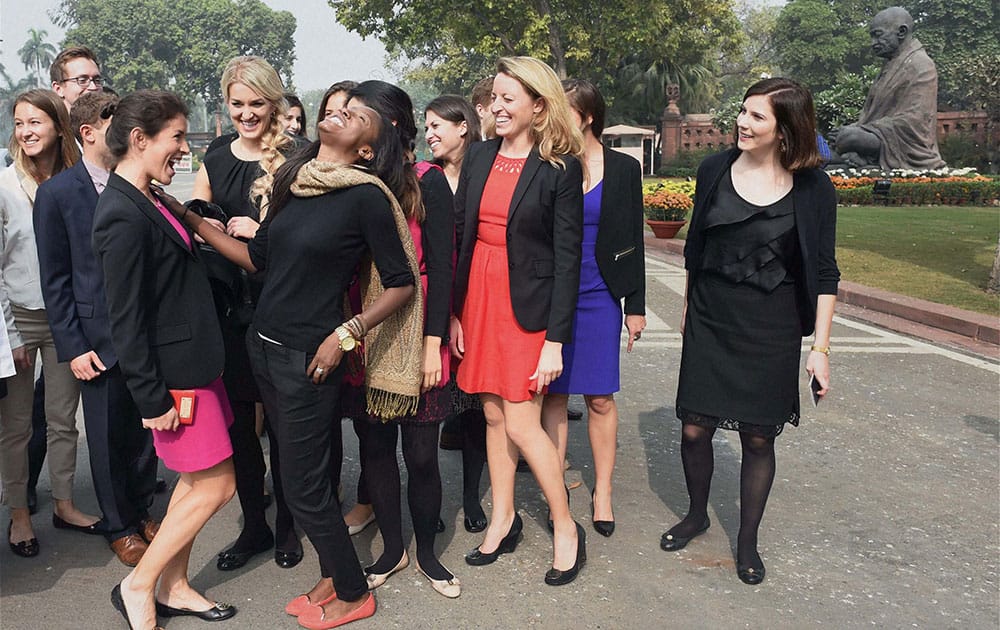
701, 169, 797, 291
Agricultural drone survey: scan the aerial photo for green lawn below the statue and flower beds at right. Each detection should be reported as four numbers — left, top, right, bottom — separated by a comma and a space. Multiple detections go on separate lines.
664, 206, 1000, 316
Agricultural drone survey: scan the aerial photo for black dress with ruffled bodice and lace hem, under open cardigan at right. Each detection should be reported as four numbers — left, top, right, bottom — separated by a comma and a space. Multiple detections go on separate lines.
676, 171, 802, 436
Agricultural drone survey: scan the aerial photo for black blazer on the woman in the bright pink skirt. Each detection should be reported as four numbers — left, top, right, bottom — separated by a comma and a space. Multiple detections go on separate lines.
93, 173, 225, 418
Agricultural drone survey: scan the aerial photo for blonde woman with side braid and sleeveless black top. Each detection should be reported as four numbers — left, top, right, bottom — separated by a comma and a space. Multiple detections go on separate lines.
192, 57, 302, 571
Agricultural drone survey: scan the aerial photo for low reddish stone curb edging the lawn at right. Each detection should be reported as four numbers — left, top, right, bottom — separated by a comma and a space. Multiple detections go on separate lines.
644, 236, 1000, 345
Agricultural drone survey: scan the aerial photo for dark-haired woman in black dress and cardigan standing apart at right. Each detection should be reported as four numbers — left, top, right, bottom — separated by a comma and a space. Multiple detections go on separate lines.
660, 78, 840, 584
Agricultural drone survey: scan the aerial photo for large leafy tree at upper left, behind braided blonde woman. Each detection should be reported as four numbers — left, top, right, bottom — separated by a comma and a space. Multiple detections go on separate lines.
53, 0, 295, 113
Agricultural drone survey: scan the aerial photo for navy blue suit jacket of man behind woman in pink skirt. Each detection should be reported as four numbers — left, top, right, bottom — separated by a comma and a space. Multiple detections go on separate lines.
32, 160, 118, 369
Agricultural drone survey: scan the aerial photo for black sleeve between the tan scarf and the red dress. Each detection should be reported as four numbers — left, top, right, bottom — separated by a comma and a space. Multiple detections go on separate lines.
420, 168, 455, 339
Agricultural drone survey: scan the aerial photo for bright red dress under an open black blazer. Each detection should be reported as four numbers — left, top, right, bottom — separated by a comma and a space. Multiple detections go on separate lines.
458, 154, 545, 402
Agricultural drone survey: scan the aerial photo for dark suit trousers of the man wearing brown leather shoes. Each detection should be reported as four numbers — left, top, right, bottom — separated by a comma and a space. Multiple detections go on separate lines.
80, 364, 157, 542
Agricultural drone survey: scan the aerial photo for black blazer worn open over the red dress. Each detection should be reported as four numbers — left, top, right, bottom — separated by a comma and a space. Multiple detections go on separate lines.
455, 139, 583, 343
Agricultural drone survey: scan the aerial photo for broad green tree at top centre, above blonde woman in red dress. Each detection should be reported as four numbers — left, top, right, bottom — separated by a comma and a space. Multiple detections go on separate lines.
330, 0, 739, 114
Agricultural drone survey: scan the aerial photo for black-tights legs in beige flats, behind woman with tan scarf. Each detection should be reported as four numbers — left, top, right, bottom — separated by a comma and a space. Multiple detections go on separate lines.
354, 420, 446, 580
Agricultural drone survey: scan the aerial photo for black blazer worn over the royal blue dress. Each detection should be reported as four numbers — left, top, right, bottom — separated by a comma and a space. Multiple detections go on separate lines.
595, 147, 646, 315
